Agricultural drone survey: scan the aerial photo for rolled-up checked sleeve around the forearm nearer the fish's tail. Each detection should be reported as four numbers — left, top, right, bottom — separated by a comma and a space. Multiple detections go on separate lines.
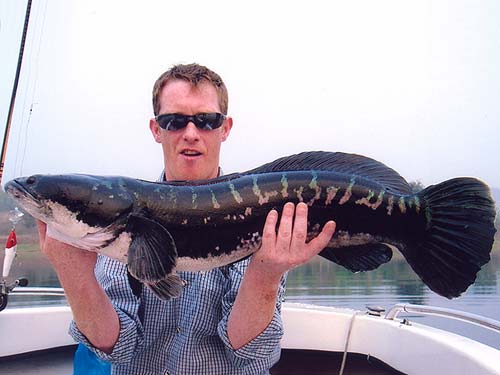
217, 260, 286, 367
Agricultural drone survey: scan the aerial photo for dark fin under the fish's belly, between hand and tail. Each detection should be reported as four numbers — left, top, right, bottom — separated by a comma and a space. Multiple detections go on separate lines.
319, 243, 392, 272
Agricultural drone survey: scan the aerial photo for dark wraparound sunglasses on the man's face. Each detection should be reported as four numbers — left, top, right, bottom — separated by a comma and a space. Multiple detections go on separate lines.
155, 112, 226, 130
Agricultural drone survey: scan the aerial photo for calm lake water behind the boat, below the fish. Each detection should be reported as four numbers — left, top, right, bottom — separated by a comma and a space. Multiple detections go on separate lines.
3, 241, 500, 349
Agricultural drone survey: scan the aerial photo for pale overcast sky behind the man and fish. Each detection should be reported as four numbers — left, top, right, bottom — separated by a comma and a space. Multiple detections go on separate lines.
0, 0, 500, 187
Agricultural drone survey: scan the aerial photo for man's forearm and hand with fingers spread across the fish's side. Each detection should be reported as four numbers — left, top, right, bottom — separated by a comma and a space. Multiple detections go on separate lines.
227, 203, 335, 349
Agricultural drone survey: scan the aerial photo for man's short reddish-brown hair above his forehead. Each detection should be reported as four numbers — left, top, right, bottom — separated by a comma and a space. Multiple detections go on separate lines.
153, 63, 229, 116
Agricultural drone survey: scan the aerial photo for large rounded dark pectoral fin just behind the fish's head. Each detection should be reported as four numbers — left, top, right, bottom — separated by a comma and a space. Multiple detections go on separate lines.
126, 215, 177, 283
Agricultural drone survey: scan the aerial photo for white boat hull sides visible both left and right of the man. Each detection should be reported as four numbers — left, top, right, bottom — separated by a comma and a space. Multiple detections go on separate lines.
0, 303, 500, 375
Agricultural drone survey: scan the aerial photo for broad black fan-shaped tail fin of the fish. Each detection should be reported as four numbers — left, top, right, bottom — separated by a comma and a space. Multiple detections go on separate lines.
402, 178, 496, 299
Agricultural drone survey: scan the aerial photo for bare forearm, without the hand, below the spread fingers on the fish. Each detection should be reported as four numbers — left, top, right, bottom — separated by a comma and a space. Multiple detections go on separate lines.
227, 262, 281, 350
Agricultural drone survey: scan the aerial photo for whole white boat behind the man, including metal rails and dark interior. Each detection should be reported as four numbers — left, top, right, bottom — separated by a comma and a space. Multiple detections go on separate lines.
0, 280, 500, 375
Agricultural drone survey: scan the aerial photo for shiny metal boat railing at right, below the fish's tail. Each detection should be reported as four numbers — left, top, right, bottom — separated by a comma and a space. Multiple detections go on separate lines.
384, 303, 500, 333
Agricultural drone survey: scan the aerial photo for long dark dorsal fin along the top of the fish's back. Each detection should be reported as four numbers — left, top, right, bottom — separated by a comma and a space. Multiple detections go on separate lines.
244, 151, 412, 194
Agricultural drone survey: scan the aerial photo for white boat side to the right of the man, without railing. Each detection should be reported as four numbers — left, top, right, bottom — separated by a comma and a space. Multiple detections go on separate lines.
282, 304, 500, 375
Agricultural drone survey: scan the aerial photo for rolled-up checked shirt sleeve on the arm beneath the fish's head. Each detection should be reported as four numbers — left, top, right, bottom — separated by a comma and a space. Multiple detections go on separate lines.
69, 256, 144, 363
